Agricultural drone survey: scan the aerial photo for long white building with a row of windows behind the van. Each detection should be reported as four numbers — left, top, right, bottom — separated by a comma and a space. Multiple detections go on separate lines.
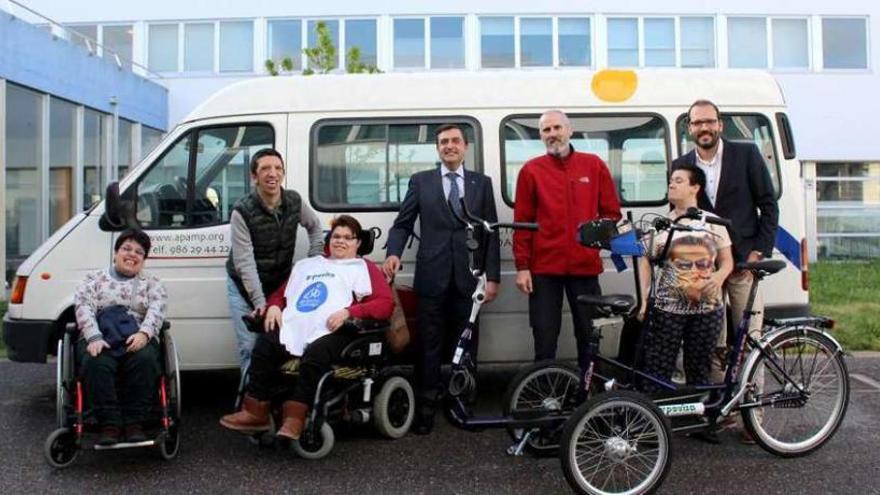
0, 0, 880, 280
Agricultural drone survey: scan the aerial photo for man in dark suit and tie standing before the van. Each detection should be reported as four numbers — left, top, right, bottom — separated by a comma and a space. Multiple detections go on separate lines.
383, 124, 500, 434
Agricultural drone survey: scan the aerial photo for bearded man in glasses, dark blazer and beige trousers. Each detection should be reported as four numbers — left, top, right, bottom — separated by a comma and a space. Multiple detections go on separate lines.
672, 100, 779, 441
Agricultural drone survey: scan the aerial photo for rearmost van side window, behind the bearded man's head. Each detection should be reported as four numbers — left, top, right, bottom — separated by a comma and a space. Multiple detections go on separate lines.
675, 113, 782, 199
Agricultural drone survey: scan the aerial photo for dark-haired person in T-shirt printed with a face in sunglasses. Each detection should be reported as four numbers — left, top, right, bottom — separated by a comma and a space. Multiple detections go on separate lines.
639, 165, 733, 392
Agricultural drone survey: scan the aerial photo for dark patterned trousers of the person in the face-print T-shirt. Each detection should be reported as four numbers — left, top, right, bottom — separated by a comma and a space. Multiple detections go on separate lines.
639, 308, 724, 393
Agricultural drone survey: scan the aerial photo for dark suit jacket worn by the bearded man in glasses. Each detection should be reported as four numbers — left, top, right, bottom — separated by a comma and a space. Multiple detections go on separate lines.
672, 140, 779, 262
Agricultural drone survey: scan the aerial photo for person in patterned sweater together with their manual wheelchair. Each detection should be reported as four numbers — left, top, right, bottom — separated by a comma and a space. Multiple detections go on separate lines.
44, 229, 180, 468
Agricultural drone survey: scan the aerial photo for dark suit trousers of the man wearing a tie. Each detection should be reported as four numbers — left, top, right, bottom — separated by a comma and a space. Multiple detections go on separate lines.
415, 287, 479, 406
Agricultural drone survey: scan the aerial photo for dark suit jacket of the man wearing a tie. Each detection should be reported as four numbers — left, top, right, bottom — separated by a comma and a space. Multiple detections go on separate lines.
387, 165, 500, 296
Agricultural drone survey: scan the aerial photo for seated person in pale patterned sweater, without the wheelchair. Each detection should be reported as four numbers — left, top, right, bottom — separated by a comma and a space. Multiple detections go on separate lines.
74, 229, 167, 445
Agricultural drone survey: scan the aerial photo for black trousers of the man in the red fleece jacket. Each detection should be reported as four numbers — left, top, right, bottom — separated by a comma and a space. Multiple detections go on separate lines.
529, 275, 602, 368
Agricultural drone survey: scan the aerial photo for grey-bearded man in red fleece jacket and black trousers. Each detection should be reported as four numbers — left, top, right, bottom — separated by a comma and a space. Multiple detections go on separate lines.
513, 110, 621, 372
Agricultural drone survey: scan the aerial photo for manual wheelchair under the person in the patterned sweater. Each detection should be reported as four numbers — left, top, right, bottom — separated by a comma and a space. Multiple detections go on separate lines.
43, 321, 181, 469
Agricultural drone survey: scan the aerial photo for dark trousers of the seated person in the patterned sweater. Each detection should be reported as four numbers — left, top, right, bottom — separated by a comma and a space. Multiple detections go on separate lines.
76, 339, 162, 427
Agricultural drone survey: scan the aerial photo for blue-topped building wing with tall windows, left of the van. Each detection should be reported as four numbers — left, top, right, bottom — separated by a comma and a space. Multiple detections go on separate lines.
0, 0, 168, 282
